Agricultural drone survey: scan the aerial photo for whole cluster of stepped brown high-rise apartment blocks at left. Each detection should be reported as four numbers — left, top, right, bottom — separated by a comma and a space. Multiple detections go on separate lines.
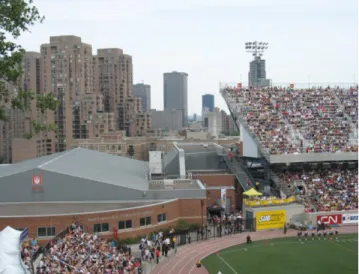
0, 36, 152, 162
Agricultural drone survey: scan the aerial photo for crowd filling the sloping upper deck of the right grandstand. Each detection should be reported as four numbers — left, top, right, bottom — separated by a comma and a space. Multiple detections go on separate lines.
225, 87, 358, 154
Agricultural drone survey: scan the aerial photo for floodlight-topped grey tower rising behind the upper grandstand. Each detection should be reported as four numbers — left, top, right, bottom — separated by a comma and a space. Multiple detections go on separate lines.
245, 41, 270, 88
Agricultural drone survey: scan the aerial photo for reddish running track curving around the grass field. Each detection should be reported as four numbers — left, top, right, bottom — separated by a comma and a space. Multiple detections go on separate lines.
151, 226, 358, 274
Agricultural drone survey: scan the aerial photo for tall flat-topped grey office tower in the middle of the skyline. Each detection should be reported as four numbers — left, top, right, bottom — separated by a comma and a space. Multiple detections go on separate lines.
163, 71, 188, 126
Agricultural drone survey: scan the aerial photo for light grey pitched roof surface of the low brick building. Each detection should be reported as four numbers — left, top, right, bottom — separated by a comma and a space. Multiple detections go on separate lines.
0, 148, 149, 190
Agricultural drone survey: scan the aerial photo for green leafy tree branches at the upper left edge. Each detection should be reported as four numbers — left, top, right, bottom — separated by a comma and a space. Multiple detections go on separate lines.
0, 0, 58, 138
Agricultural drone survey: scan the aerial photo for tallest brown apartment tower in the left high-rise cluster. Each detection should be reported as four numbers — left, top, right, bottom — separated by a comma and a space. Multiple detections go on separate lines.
40, 36, 95, 152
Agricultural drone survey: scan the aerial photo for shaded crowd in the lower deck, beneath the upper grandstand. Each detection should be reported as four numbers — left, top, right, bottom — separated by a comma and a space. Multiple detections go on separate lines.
276, 167, 358, 211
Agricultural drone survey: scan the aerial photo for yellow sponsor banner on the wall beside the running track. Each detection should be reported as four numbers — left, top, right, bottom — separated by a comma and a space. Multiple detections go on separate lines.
256, 210, 287, 230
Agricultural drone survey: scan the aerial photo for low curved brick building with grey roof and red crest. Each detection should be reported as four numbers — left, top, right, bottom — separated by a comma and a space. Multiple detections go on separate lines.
0, 148, 207, 241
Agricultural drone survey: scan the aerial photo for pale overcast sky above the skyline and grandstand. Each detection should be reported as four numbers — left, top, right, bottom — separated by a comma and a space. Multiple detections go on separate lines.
20, 0, 358, 114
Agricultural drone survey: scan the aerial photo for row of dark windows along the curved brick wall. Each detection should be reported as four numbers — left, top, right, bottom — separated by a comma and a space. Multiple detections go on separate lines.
31, 213, 167, 237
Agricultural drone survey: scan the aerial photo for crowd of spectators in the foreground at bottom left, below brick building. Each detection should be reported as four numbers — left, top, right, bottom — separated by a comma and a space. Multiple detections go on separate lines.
30, 223, 140, 274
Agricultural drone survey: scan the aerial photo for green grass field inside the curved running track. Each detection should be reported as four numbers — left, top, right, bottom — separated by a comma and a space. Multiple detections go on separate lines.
202, 234, 358, 274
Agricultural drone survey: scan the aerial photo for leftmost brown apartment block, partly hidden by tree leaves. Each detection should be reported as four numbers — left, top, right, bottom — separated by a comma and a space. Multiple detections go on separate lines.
0, 52, 54, 163
